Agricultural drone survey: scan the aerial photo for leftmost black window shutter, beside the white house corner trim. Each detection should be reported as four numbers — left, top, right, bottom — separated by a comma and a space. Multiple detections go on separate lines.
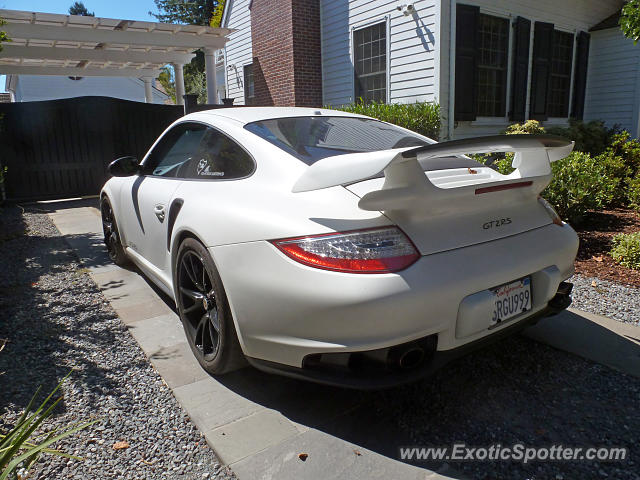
454, 5, 480, 120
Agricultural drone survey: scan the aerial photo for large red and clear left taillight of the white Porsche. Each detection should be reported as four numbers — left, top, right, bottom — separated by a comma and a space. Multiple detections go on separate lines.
272, 227, 420, 273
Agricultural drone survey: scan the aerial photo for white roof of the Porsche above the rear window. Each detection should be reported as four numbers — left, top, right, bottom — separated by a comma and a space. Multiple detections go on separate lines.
185, 107, 369, 125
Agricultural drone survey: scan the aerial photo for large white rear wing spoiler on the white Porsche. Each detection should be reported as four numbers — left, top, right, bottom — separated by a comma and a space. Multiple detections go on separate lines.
292, 134, 574, 193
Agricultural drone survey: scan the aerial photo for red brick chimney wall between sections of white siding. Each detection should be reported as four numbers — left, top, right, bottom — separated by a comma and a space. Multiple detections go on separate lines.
251, 0, 322, 107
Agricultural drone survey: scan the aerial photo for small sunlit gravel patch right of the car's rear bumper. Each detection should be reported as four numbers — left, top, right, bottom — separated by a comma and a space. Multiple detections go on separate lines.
569, 275, 640, 326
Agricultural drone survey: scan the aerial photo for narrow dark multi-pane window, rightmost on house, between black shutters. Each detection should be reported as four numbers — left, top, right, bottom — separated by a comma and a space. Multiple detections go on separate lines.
547, 30, 573, 117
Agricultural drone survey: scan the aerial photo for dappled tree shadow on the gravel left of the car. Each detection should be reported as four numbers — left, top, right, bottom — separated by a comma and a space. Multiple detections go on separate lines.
0, 204, 146, 415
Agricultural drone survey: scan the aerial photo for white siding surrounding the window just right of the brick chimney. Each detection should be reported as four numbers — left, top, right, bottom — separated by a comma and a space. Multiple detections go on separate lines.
320, 0, 440, 106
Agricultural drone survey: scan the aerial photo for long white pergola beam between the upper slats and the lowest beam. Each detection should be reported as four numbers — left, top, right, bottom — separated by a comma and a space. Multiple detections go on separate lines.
0, 44, 195, 65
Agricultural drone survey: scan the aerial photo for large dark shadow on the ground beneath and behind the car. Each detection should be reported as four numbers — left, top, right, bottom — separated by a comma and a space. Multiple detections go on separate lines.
212, 327, 640, 478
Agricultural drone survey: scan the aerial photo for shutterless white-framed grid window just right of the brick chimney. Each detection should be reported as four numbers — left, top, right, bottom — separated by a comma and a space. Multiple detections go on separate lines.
353, 22, 387, 103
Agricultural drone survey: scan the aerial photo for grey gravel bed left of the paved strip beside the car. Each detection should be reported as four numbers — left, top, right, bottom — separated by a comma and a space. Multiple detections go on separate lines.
0, 207, 234, 479
